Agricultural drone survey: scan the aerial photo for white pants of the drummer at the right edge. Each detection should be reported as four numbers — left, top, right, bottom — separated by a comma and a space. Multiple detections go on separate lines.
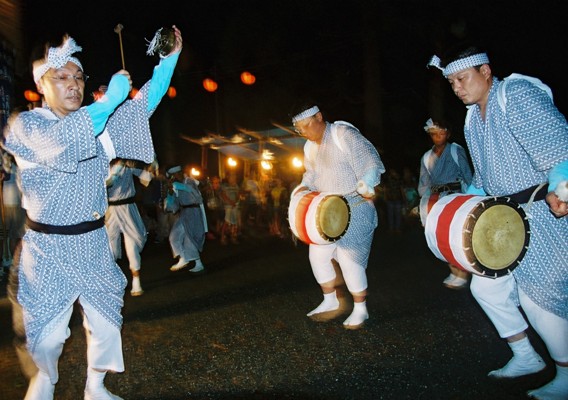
470, 274, 568, 362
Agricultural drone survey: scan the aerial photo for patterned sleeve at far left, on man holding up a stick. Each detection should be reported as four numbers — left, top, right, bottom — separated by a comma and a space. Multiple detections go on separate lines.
4, 108, 97, 173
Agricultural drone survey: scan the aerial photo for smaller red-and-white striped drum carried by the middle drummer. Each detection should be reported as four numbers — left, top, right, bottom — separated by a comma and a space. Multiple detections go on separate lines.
288, 190, 351, 244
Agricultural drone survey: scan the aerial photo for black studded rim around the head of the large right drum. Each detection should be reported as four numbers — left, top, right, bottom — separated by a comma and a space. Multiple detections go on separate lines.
462, 196, 531, 278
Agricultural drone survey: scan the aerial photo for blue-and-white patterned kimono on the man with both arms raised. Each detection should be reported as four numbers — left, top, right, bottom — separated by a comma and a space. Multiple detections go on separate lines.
3, 55, 178, 352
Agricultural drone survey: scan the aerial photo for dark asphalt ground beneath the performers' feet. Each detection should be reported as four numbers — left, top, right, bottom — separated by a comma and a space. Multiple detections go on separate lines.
0, 219, 554, 400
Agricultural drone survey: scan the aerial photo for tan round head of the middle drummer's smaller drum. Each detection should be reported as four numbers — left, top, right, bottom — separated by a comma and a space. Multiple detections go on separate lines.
316, 195, 350, 241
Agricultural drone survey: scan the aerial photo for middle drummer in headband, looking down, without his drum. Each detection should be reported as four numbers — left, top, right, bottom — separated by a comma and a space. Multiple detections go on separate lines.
291, 101, 385, 329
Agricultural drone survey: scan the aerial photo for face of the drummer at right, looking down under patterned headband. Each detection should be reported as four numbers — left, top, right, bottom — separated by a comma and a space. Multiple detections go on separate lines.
448, 65, 492, 105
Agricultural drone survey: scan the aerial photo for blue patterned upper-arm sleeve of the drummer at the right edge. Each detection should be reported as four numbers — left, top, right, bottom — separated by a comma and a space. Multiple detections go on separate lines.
506, 79, 568, 171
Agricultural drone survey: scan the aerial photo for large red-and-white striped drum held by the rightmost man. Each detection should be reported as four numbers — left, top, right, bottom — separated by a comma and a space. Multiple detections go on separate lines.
425, 193, 530, 277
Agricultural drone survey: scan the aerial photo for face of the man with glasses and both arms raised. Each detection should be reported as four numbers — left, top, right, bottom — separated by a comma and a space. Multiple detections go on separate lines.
37, 61, 86, 117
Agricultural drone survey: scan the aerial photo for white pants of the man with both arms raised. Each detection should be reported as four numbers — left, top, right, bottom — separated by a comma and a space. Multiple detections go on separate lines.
32, 297, 124, 384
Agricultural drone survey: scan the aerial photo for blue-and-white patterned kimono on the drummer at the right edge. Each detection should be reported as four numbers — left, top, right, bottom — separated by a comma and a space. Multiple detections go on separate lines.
464, 78, 568, 319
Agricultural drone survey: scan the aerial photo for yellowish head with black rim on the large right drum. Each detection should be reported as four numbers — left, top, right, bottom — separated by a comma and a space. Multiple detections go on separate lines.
471, 198, 530, 276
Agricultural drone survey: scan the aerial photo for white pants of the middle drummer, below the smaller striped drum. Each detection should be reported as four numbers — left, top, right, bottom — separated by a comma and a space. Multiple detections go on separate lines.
310, 243, 367, 293
